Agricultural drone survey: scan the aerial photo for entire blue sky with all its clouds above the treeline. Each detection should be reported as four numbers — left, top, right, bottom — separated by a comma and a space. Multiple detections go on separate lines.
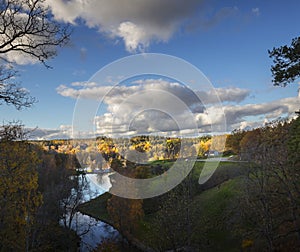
0, 0, 300, 139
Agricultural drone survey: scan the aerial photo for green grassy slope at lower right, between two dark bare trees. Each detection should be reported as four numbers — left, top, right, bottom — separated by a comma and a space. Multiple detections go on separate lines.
193, 178, 241, 251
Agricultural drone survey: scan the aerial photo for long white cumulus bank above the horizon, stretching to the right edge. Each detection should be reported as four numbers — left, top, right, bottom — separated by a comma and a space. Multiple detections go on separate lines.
52, 78, 300, 139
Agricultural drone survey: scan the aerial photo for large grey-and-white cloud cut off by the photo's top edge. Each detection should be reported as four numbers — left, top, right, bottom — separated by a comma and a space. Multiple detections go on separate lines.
46, 0, 203, 52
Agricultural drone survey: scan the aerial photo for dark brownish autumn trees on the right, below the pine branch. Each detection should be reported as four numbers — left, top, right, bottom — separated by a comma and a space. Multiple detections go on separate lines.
241, 118, 300, 250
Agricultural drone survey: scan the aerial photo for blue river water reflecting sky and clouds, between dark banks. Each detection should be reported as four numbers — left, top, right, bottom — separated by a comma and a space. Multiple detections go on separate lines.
68, 174, 119, 252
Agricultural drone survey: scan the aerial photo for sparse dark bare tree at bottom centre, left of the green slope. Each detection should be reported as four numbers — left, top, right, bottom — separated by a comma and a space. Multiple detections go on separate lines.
154, 161, 198, 251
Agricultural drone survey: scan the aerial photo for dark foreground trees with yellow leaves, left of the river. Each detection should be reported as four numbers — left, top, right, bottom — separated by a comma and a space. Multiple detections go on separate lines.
0, 123, 82, 251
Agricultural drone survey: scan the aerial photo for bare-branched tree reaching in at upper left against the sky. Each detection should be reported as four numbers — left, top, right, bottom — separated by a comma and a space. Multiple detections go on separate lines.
0, 0, 70, 109
